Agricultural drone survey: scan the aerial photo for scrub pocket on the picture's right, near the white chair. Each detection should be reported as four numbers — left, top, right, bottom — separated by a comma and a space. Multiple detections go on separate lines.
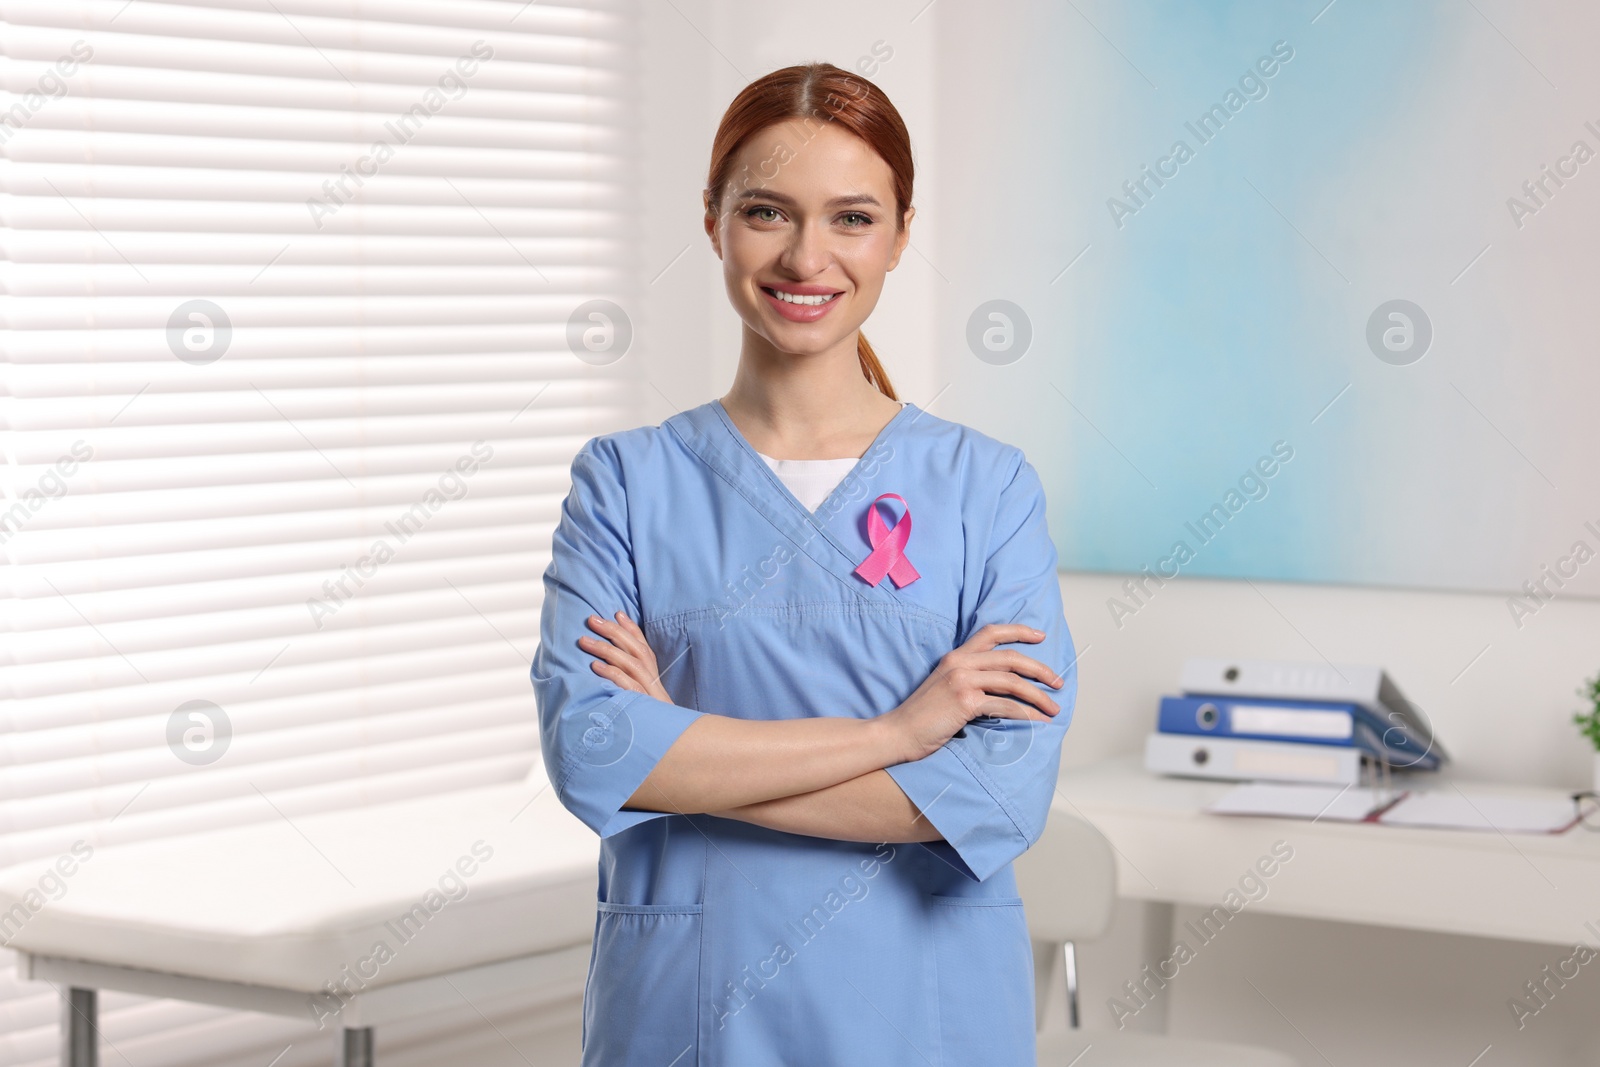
930, 896, 1035, 1067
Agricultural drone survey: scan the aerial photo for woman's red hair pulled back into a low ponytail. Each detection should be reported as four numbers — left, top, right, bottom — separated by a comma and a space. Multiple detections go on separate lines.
706, 62, 915, 400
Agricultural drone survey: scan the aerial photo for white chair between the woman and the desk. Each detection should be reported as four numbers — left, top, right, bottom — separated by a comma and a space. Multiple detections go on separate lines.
1014, 811, 1298, 1067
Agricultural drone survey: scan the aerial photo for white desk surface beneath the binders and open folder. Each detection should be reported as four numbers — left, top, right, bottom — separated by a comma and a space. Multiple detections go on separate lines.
1054, 757, 1600, 945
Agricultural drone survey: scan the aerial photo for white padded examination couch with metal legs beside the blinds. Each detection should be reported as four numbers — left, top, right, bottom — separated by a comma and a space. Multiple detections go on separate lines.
0, 777, 600, 1067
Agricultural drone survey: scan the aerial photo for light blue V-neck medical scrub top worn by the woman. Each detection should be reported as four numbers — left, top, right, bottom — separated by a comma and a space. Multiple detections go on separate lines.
531, 400, 1077, 1067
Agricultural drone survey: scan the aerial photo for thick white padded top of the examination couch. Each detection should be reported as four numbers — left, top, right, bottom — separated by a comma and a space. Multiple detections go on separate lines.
0, 776, 600, 993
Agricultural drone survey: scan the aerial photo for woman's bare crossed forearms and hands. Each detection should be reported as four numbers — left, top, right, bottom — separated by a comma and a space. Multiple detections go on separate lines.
578, 611, 1062, 841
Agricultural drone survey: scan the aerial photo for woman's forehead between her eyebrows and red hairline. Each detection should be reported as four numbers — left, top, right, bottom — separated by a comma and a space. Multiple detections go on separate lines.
730, 118, 894, 206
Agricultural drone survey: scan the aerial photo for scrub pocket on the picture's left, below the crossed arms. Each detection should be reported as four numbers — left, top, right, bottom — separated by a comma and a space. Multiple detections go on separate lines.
582, 901, 702, 1067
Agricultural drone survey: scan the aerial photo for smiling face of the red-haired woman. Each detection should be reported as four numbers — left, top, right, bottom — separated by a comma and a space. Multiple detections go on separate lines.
706, 122, 914, 355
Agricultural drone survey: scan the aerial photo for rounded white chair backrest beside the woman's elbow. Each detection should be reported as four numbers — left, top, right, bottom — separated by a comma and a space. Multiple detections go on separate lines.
1013, 809, 1117, 942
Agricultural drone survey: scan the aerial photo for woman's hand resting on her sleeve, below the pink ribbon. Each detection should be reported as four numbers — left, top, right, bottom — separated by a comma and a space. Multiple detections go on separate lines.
880, 622, 1066, 761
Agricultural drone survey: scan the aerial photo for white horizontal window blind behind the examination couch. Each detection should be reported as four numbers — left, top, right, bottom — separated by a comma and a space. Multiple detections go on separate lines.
0, 0, 637, 1067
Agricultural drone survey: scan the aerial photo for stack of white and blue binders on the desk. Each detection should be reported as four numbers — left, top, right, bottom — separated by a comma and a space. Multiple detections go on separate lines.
1144, 659, 1448, 785
